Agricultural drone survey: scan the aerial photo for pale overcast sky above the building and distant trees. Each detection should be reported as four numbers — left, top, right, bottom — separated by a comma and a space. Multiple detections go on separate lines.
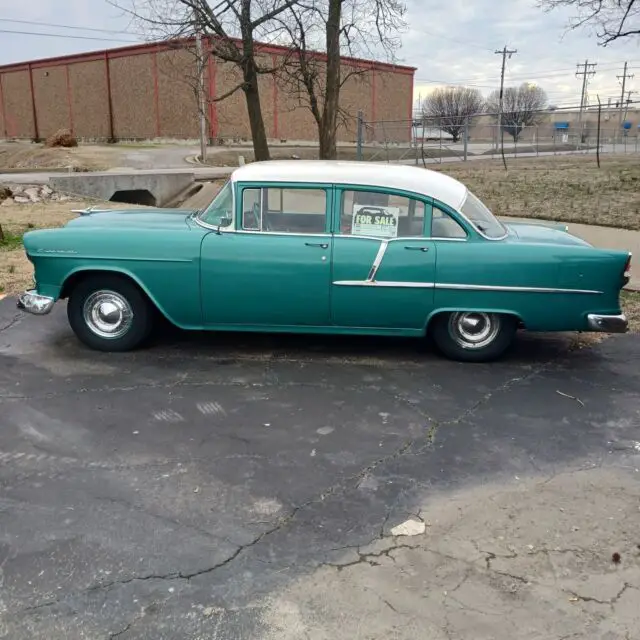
0, 0, 640, 105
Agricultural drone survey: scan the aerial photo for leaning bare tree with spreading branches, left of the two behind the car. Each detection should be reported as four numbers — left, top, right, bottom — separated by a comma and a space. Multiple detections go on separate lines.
109, 0, 299, 160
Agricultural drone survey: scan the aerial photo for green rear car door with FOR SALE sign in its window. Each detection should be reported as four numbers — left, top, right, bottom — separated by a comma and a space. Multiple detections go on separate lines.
331, 187, 436, 330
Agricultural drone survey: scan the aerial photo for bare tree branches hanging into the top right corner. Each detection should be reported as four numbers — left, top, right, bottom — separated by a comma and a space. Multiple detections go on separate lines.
538, 0, 640, 46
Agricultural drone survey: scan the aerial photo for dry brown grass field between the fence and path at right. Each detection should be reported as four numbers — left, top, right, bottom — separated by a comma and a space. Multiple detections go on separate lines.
438, 154, 640, 229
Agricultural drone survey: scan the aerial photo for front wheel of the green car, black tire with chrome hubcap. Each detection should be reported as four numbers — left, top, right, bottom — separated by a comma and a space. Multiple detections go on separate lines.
67, 274, 153, 351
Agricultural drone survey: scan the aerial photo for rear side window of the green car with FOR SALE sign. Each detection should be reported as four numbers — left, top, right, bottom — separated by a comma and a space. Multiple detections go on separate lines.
340, 190, 425, 238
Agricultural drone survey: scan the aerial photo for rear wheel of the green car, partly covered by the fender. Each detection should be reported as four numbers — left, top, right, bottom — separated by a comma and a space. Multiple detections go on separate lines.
431, 311, 517, 362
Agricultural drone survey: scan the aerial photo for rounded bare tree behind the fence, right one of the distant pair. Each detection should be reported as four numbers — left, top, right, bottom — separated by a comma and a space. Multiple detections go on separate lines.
486, 82, 547, 142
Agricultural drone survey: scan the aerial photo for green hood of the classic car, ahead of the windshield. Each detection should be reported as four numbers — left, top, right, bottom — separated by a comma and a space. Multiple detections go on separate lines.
67, 209, 198, 230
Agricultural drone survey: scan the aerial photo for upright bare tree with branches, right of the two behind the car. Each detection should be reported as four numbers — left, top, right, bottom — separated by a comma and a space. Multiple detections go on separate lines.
275, 0, 406, 159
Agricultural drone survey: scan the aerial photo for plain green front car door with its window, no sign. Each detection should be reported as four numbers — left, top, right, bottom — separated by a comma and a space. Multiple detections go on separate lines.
201, 184, 333, 327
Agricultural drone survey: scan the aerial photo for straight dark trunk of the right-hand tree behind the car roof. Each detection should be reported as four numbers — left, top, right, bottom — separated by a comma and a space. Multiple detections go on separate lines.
318, 0, 343, 160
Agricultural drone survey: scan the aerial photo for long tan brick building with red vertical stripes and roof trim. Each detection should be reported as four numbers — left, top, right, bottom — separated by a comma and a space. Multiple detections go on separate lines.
0, 40, 415, 141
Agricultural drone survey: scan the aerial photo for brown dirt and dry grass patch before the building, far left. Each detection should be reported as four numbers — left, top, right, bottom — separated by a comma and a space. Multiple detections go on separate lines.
0, 142, 122, 173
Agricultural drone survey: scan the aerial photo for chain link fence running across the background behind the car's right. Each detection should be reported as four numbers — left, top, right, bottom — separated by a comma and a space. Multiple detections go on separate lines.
357, 110, 640, 164
